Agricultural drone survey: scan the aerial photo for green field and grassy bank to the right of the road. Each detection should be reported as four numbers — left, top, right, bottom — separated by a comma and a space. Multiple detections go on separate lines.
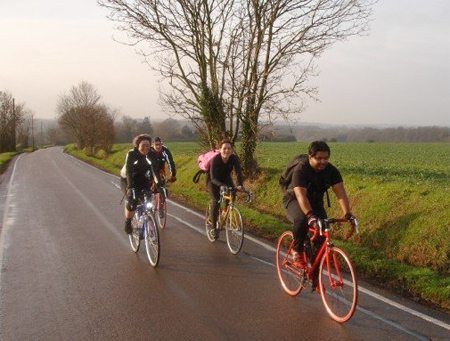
65, 143, 450, 310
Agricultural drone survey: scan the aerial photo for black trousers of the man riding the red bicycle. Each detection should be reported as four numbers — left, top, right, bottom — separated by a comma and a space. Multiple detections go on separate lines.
286, 199, 327, 252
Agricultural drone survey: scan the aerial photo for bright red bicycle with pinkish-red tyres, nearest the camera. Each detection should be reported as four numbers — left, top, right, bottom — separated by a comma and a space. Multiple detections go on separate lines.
277, 218, 358, 323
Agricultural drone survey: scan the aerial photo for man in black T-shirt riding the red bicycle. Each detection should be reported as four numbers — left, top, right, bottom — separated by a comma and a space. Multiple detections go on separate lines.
283, 141, 355, 278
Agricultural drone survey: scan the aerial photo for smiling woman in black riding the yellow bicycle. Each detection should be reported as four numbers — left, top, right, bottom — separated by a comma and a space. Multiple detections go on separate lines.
206, 139, 244, 238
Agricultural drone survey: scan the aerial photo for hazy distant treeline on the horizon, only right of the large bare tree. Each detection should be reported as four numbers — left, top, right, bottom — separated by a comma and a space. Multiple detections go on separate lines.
261, 125, 450, 142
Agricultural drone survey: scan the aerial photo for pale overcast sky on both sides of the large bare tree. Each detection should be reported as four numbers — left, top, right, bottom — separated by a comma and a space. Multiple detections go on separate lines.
0, 0, 450, 126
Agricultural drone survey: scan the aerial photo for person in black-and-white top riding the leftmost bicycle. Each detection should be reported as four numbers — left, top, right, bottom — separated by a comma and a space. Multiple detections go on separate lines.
120, 134, 161, 234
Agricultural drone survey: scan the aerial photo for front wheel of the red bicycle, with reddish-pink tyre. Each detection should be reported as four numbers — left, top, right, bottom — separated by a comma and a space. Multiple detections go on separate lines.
319, 247, 358, 323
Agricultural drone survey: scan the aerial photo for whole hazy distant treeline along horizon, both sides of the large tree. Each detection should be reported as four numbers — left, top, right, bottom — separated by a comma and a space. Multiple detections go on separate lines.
35, 116, 450, 145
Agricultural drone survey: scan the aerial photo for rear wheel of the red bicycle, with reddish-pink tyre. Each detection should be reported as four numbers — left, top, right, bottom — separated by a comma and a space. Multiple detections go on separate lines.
277, 231, 304, 296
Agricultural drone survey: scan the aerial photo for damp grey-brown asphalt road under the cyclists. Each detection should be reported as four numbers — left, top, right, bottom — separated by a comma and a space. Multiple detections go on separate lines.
0, 147, 450, 341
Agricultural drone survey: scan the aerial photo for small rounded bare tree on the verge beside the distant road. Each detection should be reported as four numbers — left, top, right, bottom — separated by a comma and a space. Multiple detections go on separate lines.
57, 82, 115, 154
